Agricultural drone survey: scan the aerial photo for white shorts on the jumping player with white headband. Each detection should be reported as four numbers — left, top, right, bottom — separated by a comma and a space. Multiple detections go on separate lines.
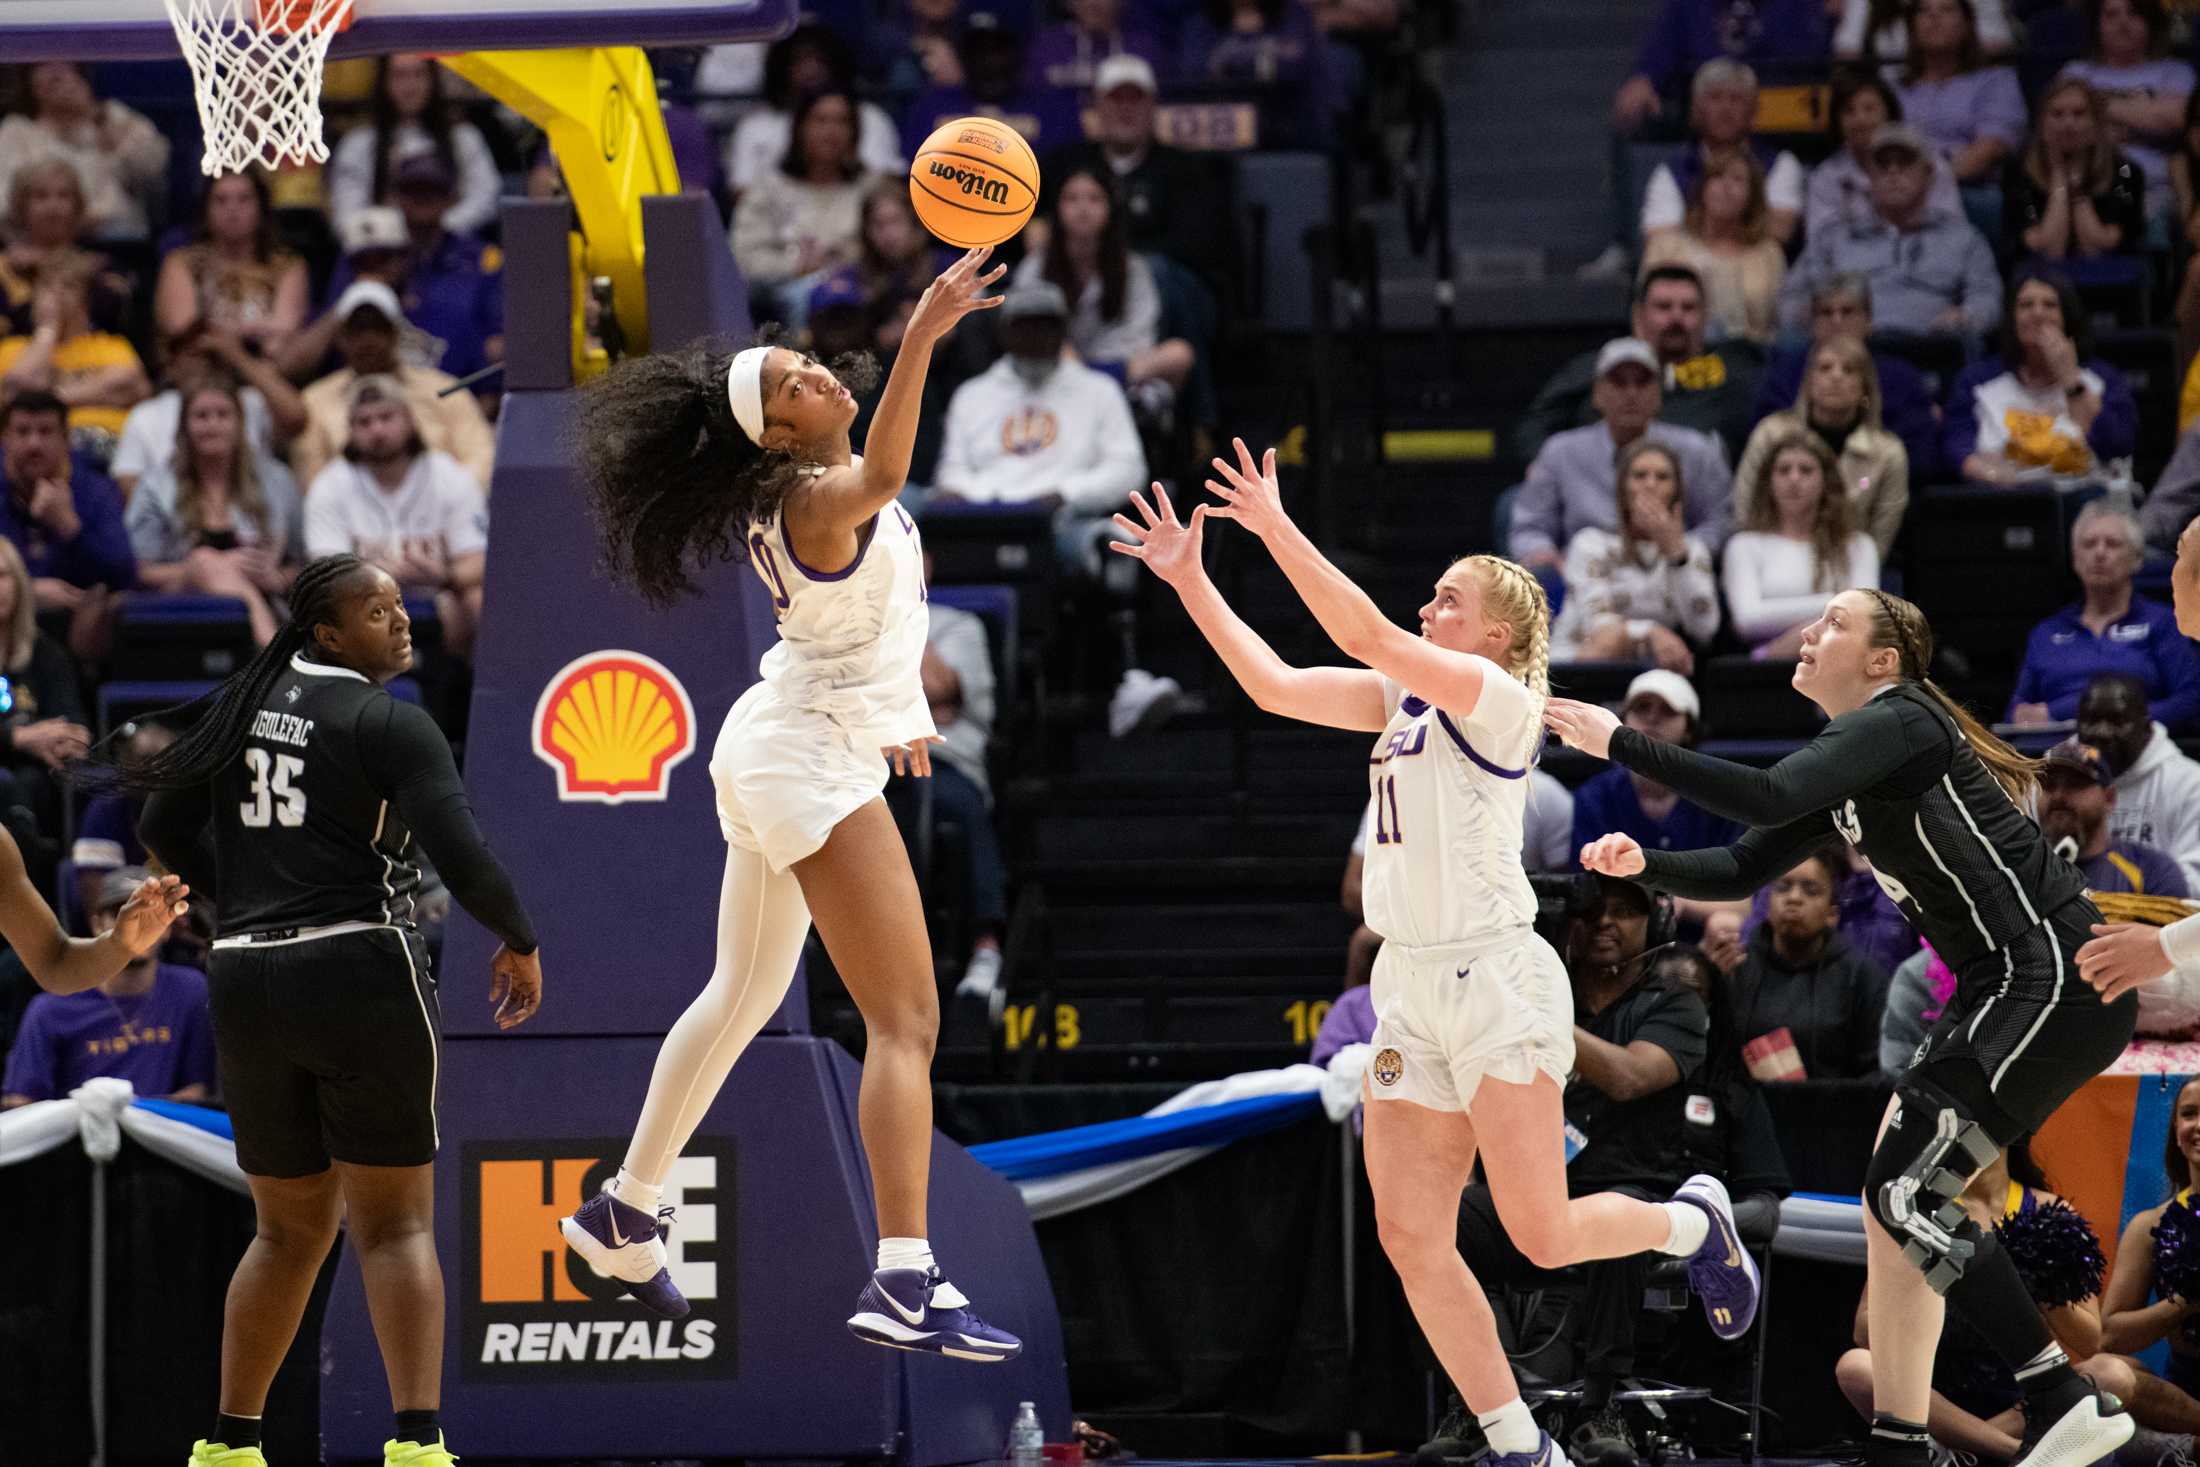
711, 682, 889, 871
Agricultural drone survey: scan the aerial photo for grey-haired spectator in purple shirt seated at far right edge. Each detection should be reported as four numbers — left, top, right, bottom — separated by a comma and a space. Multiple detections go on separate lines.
2009, 499, 2200, 732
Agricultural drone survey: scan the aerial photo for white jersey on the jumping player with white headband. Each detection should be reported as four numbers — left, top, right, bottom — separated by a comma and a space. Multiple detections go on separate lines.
748, 457, 939, 748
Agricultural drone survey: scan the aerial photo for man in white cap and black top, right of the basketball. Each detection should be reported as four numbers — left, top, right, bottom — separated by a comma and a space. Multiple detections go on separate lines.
1025, 53, 1234, 290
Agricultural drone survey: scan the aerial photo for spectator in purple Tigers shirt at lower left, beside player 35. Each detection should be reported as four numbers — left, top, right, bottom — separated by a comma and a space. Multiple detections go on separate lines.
0, 867, 216, 1106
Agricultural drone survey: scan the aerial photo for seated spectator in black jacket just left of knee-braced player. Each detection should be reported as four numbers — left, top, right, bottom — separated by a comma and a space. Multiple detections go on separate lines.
1734, 847, 1888, 1080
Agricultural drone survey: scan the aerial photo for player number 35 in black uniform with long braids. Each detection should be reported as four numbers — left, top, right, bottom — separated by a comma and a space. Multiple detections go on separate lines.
101, 554, 541, 1467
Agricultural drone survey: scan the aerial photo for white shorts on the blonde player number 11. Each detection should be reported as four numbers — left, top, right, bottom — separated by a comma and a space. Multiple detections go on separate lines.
1366, 928, 1573, 1111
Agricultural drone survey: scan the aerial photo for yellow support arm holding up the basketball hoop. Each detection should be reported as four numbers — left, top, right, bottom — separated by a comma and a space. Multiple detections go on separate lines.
440, 46, 680, 383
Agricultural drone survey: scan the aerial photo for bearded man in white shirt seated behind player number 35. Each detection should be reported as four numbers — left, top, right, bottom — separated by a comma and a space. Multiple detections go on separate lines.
306, 374, 488, 653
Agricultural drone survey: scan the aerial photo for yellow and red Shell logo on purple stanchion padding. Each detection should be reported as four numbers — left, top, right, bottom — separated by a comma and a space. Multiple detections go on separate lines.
535, 651, 695, 805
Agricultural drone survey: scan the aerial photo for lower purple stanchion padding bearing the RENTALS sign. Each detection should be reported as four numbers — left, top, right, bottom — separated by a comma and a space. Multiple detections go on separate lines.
321, 1036, 1069, 1467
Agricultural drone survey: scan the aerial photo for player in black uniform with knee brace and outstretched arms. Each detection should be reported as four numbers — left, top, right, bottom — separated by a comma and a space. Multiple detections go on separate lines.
1547, 589, 2138, 1467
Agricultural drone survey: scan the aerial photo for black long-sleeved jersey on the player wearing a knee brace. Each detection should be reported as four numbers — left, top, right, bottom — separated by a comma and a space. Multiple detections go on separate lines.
1613, 682, 2086, 979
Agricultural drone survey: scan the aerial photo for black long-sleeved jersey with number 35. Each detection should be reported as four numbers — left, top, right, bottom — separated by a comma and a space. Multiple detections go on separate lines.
141, 658, 535, 952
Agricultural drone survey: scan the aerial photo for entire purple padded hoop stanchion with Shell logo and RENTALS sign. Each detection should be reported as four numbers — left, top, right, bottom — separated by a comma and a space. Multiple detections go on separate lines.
321, 196, 1069, 1467
